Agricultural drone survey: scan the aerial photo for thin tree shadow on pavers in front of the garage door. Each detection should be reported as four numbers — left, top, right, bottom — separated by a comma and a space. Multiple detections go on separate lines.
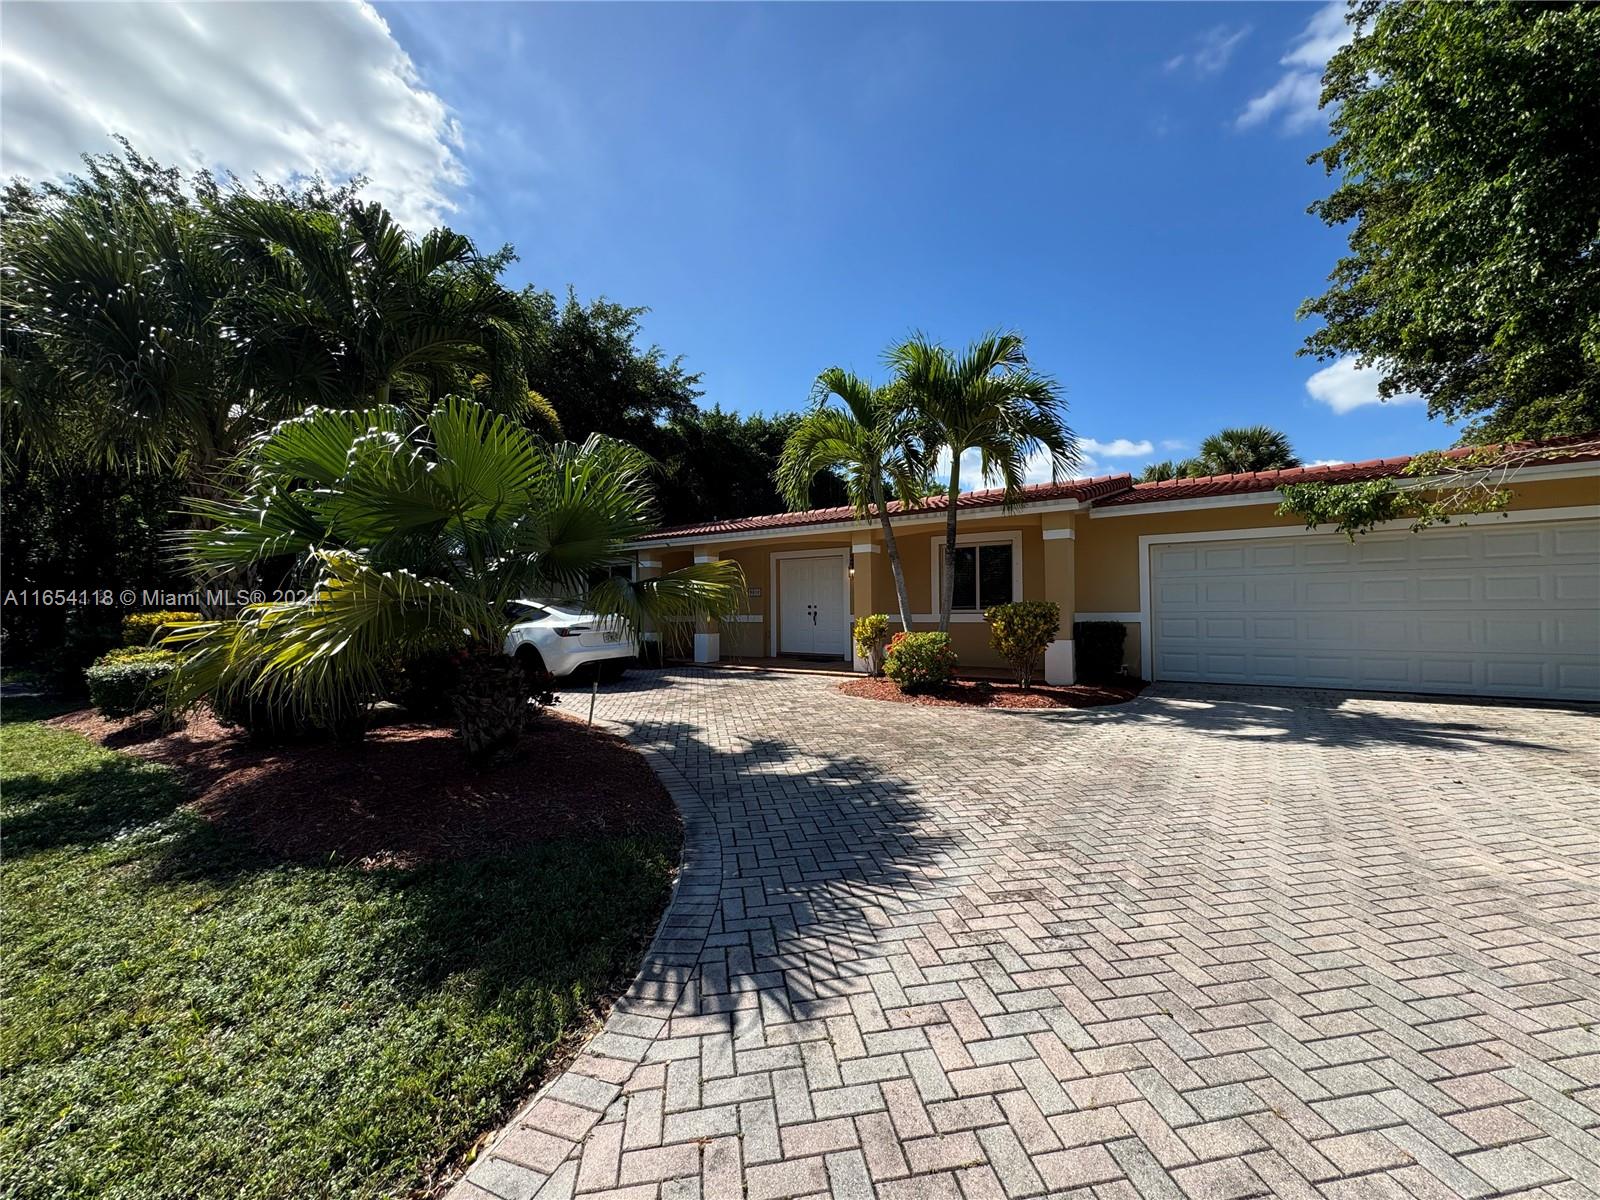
1035, 683, 1570, 752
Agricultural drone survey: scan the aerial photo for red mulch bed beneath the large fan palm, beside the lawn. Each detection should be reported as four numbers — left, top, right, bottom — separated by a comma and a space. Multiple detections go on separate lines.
53, 710, 678, 867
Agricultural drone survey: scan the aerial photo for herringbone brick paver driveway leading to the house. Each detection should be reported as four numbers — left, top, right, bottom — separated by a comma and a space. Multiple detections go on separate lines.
458, 670, 1600, 1200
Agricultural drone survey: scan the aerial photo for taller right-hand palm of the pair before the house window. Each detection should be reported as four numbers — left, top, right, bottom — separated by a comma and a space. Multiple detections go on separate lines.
886, 333, 1078, 632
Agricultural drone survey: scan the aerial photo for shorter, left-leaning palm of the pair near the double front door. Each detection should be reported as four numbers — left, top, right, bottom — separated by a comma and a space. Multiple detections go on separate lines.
778, 366, 926, 632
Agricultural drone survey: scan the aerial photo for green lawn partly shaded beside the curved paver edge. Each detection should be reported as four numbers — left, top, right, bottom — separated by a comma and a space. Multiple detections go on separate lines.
0, 701, 675, 1200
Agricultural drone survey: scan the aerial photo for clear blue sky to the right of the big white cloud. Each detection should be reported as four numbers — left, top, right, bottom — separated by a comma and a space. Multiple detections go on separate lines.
381, 5, 1453, 480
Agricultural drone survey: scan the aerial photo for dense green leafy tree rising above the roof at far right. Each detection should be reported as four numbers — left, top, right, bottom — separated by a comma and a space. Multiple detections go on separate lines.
1301, 0, 1600, 443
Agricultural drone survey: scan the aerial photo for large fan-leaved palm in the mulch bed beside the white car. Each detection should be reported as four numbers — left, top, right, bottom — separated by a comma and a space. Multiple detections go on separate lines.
166, 398, 742, 757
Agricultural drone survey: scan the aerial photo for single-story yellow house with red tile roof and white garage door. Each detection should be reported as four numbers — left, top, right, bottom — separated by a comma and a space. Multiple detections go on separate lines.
635, 441, 1600, 701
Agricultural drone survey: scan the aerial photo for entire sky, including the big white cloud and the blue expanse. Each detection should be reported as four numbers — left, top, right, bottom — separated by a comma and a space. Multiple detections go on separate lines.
0, 0, 1454, 483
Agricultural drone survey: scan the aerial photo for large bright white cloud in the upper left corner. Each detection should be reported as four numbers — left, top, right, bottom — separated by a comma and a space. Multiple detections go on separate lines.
0, 0, 466, 229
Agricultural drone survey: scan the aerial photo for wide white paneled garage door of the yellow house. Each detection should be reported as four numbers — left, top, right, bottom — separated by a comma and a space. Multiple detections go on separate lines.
1150, 518, 1600, 699
